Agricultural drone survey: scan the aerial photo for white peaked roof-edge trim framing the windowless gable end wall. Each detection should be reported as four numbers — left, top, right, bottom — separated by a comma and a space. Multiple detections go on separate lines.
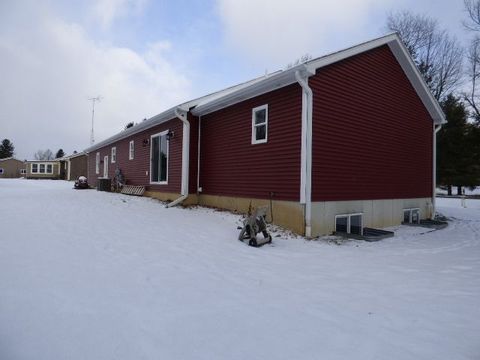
307, 33, 446, 125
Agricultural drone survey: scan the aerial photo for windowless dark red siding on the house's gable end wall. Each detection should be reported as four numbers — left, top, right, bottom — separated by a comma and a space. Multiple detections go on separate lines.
309, 46, 433, 201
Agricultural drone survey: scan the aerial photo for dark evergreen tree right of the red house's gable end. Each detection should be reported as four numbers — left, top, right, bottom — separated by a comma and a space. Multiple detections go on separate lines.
437, 94, 480, 194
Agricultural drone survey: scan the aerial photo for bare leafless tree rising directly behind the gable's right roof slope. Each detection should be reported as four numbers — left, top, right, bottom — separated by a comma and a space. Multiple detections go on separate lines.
387, 11, 463, 100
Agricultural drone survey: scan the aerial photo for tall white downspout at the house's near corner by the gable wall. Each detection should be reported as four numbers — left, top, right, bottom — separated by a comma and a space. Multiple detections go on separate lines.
295, 70, 313, 238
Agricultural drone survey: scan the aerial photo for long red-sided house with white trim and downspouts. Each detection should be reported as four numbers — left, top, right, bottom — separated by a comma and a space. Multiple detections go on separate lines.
86, 34, 445, 236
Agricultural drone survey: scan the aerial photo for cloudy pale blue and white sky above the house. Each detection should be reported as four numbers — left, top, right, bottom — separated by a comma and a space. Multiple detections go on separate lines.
0, 0, 469, 159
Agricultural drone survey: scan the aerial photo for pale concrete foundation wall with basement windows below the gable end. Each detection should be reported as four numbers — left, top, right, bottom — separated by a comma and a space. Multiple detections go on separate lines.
312, 198, 432, 236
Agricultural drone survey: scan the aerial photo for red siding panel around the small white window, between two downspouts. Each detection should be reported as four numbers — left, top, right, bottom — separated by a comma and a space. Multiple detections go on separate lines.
200, 84, 302, 200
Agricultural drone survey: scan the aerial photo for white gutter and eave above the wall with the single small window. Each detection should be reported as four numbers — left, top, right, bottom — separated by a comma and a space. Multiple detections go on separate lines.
192, 64, 314, 116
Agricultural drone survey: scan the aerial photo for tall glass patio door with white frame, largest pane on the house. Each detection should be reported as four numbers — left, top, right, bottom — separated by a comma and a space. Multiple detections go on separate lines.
150, 131, 168, 184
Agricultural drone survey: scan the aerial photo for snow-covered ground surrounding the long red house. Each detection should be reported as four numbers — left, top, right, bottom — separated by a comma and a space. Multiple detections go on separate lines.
0, 179, 480, 360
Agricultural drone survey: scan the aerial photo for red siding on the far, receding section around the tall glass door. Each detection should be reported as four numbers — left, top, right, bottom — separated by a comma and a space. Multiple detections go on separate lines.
88, 119, 182, 193
